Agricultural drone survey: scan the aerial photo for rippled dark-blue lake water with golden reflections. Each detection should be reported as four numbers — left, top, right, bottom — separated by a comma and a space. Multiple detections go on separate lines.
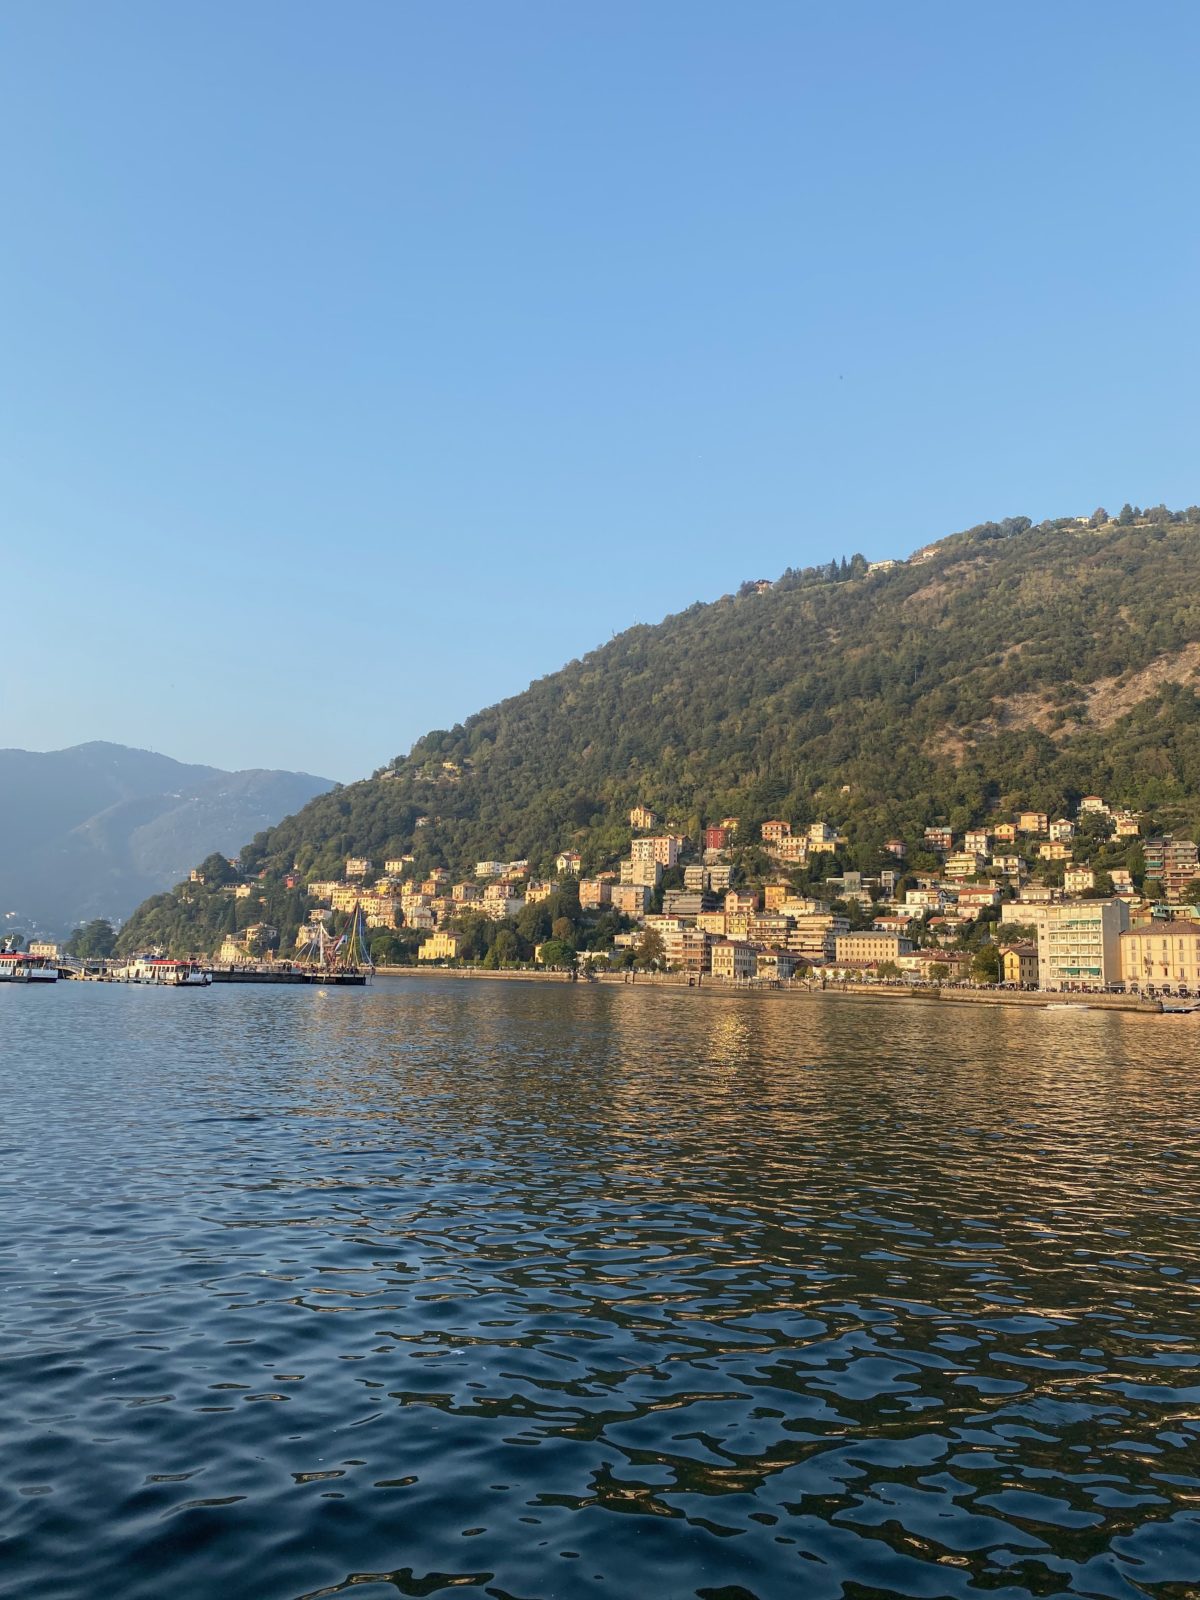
0, 979, 1200, 1600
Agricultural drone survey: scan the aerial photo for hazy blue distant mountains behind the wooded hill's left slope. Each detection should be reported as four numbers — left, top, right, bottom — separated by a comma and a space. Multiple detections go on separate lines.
0, 742, 334, 934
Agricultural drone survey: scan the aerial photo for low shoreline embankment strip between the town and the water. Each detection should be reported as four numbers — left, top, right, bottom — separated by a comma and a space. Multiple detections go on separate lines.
376, 966, 1163, 1016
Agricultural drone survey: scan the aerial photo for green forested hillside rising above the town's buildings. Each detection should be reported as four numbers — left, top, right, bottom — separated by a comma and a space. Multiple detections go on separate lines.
125, 507, 1200, 949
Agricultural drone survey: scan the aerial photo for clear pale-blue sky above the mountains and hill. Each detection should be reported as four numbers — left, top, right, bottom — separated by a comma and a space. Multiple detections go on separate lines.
0, 0, 1200, 779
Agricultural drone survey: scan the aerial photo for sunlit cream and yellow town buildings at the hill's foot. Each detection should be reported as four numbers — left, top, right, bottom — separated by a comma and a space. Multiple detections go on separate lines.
218, 795, 1200, 995
